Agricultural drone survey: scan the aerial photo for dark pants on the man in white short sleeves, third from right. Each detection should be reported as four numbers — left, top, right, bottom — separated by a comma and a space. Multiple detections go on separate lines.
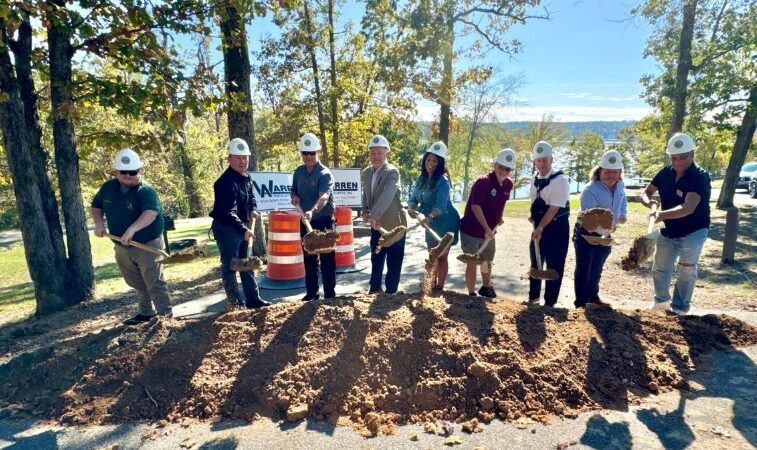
528, 216, 570, 306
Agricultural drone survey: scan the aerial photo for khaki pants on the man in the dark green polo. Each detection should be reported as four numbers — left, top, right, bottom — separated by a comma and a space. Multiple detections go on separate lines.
115, 238, 171, 316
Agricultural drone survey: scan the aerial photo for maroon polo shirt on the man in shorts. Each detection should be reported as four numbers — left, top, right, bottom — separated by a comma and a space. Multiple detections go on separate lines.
460, 172, 513, 239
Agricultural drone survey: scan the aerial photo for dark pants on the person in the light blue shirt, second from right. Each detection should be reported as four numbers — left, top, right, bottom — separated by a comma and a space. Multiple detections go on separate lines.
573, 224, 612, 308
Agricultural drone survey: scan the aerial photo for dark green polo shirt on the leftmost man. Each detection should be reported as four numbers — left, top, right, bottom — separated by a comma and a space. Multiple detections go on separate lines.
92, 178, 163, 243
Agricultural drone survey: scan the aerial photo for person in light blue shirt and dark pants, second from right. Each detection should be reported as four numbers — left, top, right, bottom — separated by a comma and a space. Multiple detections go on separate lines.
573, 150, 628, 308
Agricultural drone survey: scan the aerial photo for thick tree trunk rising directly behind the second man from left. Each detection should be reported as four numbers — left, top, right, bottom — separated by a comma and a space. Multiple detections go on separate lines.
221, 6, 258, 170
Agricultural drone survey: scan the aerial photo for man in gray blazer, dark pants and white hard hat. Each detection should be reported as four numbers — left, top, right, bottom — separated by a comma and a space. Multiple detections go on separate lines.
361, 134, 407, 294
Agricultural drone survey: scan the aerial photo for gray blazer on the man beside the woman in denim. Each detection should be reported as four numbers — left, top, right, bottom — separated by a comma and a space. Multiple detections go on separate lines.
360, 163, 407, 230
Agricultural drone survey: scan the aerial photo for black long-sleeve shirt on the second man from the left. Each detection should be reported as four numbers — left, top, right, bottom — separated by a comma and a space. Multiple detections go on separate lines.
210, 167, 258, 234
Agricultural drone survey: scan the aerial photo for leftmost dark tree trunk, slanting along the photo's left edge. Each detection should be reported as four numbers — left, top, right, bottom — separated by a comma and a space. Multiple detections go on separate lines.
0, 18, 74, 314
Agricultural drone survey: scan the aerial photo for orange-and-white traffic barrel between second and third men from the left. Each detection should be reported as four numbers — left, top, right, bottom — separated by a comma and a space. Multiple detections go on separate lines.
260, 211, 305, 289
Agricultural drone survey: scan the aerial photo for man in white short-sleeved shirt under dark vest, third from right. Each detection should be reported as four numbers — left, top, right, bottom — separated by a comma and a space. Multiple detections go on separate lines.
528, 141, 570, 306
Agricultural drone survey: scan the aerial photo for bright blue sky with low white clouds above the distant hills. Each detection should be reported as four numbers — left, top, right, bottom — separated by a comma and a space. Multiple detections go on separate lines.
201, 0, 658, 122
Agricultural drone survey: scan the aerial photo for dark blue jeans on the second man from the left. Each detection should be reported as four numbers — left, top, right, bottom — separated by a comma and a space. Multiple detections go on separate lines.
211, 221, 260, 308
